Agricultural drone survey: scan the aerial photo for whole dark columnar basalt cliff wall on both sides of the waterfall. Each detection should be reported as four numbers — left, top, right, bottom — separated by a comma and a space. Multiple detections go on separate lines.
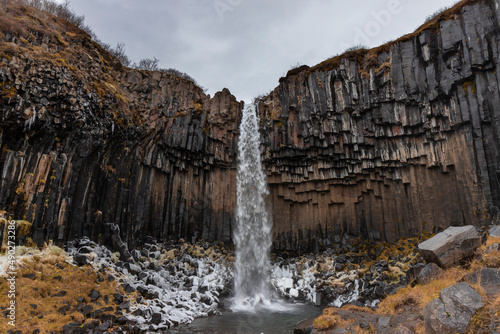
0, 0, 500, 249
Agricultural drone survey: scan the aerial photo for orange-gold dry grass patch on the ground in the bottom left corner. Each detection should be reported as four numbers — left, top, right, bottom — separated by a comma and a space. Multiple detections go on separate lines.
0, 245, 123, 333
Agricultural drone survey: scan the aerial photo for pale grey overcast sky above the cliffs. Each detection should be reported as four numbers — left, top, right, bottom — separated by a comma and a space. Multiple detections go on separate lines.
58, 0, 456, 101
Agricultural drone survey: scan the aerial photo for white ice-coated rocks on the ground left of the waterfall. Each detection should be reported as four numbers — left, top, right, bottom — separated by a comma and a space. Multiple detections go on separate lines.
68, 241, 233, 328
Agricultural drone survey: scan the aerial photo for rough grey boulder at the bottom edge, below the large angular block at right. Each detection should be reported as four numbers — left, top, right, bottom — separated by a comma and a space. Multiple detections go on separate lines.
424, 283, 484, 334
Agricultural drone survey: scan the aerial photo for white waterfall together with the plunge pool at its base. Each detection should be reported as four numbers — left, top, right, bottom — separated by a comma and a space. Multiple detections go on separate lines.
176, 105, 320, 334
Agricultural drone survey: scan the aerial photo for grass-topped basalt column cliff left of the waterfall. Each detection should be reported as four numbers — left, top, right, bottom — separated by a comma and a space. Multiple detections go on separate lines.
0, 1, 242, 245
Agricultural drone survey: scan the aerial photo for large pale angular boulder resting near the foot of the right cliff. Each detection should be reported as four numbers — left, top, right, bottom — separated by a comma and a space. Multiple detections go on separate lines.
418, 226, 481, 267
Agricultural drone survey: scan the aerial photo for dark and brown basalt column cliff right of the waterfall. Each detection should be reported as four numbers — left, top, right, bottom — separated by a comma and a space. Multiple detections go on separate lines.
259, 1, 500, 249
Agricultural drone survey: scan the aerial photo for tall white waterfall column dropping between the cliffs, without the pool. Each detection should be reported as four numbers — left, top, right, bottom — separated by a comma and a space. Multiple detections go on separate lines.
233, 105, 272, 310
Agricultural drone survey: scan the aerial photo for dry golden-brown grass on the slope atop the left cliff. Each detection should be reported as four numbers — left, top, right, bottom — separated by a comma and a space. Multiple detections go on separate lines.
0, 1, 145, 127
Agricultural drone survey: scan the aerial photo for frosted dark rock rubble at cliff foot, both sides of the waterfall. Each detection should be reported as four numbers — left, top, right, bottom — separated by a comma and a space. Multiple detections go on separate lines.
56, 234, 426, 333
